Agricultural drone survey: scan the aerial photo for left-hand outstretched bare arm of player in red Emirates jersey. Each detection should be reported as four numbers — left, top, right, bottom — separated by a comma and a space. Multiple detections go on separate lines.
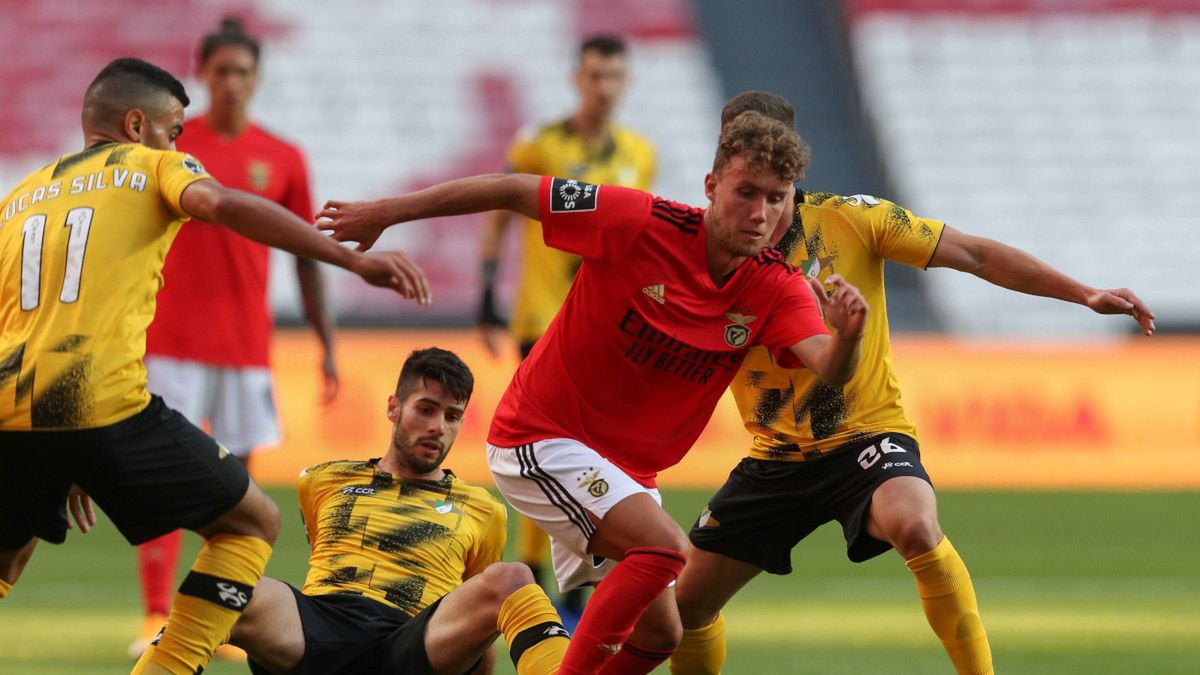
317, 173, 541, 251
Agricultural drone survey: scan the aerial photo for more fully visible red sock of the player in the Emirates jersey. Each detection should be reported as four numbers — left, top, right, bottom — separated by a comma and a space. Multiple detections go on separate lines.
558, 548, 688, 675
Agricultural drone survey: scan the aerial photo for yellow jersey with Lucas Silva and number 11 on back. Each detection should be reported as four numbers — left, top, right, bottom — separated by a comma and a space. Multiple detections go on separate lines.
0, 143, 217, 430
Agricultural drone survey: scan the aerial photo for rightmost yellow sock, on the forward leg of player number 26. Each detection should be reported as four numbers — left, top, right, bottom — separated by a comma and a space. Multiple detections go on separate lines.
905, 538, 994, 675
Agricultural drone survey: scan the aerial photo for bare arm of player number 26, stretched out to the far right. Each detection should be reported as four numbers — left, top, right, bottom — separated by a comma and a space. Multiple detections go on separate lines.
929, 227, 1156, 335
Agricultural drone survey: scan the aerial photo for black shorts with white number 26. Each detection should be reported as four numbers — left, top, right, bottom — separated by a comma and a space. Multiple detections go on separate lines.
688, 434, 930, 574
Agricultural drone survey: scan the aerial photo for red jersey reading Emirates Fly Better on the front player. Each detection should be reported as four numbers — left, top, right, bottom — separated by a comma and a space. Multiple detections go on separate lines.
488, 177, 828, 486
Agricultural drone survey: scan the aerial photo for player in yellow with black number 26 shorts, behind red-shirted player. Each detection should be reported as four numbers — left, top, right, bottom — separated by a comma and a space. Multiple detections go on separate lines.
671, 91, 1154, 675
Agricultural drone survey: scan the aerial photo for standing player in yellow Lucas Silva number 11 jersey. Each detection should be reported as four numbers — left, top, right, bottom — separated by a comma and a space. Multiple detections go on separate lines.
0, 59, 428, 673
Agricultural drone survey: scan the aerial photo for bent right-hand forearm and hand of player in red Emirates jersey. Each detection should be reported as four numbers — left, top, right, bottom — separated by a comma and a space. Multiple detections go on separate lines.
791, 274, 868, 387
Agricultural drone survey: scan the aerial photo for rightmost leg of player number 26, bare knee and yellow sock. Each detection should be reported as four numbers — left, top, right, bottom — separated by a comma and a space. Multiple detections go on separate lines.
866, 476, 994, 674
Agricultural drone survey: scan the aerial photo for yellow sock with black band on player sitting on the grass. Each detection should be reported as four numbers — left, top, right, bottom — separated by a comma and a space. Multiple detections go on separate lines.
496, 584, 570, 675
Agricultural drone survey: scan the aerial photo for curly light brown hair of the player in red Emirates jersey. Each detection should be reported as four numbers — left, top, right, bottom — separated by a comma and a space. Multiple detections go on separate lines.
713, 110, 811, 183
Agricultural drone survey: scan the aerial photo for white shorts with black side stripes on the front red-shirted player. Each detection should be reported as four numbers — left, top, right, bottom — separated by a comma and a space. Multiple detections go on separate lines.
487, 438, 662, 592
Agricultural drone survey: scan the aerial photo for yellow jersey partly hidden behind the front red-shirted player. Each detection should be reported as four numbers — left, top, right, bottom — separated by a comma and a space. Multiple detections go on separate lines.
731, 192, 946, 461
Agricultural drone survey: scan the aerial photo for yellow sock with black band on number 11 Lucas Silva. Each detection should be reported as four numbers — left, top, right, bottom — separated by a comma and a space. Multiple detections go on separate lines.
132, 534, 271, 675
